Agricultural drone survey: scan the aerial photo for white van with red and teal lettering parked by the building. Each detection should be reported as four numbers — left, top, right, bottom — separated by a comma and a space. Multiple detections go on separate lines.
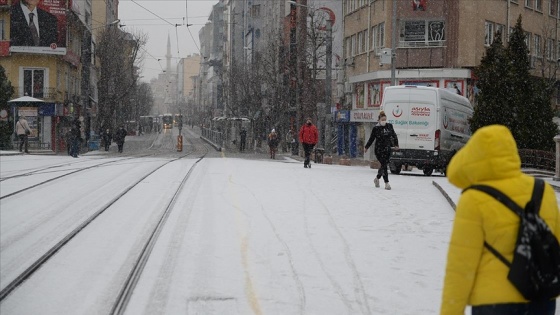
381, 86, 473, 176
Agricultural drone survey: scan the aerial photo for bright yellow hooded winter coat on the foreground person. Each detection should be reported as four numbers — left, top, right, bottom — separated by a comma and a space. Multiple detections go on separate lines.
441, 125, 560, 315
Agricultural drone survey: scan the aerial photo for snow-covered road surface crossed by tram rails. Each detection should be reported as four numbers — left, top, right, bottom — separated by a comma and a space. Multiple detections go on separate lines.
0, 154, 556, 315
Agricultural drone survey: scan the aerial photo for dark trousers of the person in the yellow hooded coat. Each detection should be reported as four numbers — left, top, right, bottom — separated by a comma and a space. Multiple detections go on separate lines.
472, 300, 556, 315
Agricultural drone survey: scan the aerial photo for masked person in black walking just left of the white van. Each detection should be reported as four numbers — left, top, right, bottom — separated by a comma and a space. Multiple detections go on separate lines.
364, 111, 399, 190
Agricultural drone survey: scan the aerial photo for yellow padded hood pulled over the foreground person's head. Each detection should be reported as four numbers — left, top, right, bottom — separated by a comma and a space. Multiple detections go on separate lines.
446, 125, 522, 189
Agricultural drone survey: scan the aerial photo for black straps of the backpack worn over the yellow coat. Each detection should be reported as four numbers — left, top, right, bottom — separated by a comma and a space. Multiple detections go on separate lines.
463, 178, 544, 267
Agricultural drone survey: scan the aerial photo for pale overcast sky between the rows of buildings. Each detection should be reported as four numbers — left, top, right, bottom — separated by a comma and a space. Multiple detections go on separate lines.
119, 0, 218, 82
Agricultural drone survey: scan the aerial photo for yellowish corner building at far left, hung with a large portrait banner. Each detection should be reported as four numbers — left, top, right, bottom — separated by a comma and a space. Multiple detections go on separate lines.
0, 0, 91, 150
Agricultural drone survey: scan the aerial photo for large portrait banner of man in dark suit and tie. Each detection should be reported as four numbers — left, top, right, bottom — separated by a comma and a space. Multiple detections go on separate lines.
10, 0, 67, 55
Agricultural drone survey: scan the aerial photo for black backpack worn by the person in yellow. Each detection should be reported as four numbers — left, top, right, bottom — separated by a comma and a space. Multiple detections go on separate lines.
463, 179, 560, 301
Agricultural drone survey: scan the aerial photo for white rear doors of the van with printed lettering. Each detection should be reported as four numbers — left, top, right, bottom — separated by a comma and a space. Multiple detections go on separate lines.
383, 87, 437, 150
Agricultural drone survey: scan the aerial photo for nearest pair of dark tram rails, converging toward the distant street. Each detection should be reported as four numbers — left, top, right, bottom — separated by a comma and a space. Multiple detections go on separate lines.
0, 136, 209, 306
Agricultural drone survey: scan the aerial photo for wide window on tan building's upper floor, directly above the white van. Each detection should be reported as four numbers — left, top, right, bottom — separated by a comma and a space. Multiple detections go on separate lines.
400, 20, 445, 47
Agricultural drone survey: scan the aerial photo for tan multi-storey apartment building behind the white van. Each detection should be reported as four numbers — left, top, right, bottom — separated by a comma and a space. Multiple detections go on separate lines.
337, 0, 559, 158
